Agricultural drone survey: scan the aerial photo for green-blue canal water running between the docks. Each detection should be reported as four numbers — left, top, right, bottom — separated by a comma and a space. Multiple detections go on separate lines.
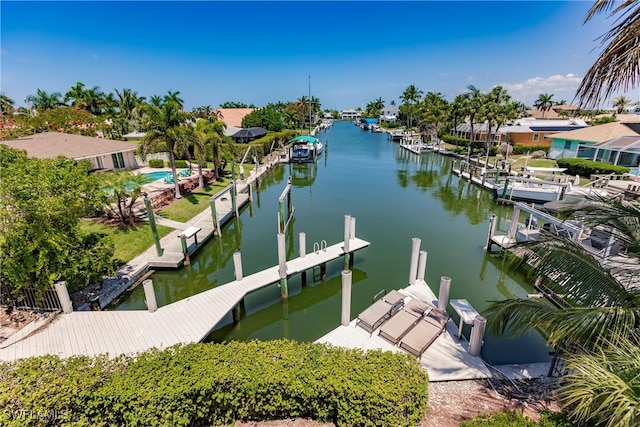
115, 122, 549, 364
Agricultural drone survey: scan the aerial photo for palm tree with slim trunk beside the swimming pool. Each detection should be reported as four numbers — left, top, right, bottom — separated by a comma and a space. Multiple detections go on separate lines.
138, 96, 189, 199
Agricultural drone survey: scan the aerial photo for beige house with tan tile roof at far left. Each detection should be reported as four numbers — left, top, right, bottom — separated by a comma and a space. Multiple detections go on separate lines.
2, 132, 138, 171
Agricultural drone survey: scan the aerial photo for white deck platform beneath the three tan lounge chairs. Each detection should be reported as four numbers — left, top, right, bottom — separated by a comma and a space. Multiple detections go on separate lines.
316, 279, 491, 381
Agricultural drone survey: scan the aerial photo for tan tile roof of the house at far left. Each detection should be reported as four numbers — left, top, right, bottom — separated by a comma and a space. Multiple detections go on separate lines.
2, 132, 138, 160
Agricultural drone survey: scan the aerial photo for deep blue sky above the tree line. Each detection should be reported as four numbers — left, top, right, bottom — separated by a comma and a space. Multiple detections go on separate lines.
0, 0, 638, 110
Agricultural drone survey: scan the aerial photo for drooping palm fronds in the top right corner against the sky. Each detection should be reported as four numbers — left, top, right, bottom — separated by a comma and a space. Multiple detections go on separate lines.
576, 0, 640, 108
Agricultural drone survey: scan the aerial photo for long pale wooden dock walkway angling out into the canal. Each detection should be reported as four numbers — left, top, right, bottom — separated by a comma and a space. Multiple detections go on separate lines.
0, 238, 369, 361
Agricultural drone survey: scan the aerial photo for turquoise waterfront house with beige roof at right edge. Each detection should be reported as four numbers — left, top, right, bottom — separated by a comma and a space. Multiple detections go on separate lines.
549, 122, 640, 173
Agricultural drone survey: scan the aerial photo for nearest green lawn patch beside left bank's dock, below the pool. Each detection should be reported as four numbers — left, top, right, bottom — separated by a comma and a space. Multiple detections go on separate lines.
80, 219, 173, 264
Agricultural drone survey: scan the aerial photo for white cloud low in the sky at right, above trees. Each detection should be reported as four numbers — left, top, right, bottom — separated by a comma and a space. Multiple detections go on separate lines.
500, 73, 582, 104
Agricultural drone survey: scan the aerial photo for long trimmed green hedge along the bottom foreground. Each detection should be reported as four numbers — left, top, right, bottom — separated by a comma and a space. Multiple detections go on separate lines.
0, 340, 428, 426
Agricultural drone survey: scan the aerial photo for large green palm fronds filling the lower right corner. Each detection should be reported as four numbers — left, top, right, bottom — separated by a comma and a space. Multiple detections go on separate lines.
485, 198, 640, 425
